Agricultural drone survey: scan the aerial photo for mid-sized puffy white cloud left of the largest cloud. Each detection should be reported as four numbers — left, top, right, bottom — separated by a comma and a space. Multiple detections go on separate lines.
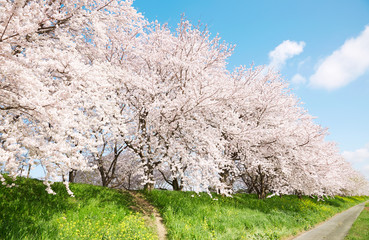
269, 40, 305, 70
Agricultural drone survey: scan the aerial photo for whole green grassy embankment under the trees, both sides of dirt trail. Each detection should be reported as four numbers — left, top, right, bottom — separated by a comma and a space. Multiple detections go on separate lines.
0, 175, 367, 240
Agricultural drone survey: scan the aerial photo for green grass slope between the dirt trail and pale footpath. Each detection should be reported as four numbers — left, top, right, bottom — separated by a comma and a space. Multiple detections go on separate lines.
145, 191, 367, 240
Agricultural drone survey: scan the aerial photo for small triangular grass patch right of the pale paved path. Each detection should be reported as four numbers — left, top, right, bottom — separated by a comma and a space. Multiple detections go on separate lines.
345, 203, 369, 240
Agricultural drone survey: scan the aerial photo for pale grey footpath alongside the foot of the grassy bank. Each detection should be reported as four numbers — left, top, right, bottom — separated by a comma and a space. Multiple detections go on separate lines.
294, 202, 365, 240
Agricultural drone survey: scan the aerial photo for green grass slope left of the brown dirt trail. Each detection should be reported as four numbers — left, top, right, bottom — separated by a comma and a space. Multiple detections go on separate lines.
0, 178, 157, 240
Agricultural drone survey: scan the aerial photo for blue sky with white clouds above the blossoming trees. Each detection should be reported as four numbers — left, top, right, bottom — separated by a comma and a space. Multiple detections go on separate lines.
133, 0, 369, 179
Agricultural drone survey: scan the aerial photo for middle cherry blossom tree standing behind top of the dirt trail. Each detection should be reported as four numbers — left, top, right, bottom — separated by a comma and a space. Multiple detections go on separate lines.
120, 19, 236, 194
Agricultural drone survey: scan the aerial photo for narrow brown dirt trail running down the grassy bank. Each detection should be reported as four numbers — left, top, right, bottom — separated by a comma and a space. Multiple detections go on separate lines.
129, 192, 167, 240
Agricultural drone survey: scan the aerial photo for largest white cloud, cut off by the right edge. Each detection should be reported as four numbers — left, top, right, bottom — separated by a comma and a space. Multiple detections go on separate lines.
310, 26, 369, 90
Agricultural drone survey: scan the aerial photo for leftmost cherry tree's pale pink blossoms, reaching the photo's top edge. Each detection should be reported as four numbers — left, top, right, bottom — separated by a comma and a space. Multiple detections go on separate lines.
0, 1, 145, 192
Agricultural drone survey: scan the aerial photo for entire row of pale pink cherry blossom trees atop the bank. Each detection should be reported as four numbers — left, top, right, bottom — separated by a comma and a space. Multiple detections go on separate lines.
0, 0, 368, 198
